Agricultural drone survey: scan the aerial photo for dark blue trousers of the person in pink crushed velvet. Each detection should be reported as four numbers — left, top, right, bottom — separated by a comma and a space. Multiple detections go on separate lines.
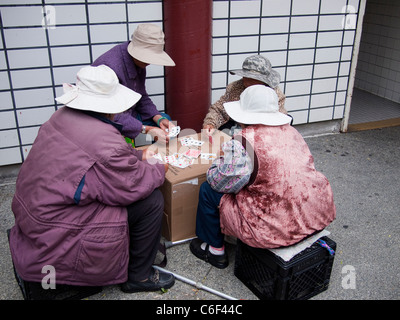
196, 181, 224, 248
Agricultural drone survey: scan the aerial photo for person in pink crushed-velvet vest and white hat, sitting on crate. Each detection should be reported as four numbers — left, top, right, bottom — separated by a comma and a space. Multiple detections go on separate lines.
190, 85, 336, 268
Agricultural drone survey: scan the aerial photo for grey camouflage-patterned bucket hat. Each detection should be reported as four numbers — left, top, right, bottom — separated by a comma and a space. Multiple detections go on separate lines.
230, 55, 281, 88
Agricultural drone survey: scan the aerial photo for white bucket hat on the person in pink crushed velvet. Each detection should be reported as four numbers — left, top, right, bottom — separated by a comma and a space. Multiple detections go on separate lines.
224, 84, 292, 126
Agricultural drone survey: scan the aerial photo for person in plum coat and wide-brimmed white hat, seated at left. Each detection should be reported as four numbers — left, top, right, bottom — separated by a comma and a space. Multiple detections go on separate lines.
10, 65, 175, 292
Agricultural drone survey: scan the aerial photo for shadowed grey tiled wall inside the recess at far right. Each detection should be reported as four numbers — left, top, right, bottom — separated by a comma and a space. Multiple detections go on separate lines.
355, 0, 400, 103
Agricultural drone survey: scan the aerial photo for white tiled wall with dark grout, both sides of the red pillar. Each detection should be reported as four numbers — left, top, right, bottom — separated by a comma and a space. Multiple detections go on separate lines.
0, 0, 362, 165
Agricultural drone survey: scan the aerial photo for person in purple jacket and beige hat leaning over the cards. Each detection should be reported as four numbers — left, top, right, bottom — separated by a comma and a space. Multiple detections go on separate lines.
92, 23, 175, 142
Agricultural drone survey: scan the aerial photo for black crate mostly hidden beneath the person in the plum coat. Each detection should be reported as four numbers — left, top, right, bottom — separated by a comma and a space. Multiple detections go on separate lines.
7, 229, 103, 300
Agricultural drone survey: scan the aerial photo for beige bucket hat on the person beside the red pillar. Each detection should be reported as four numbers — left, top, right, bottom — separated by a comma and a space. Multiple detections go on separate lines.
128, 23, 175, 67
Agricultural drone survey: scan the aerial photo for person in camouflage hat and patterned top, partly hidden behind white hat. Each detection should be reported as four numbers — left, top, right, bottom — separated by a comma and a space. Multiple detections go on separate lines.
203, 55, 287, 134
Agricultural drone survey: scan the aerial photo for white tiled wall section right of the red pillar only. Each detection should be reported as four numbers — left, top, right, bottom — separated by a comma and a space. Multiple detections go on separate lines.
212, 0, 359, 124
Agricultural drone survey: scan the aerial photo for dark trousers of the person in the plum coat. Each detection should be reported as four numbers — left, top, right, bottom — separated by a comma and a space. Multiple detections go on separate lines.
128, 189, 164, 281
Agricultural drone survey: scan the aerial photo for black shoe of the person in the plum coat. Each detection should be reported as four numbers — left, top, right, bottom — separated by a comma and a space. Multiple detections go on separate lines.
121, 269, 175, 293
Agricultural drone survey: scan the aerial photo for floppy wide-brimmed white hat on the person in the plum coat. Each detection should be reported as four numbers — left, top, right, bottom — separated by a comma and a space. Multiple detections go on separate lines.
56, 65, 142, 114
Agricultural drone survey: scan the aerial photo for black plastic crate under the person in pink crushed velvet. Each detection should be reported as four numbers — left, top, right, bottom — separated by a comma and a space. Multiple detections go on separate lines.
234, 237, 336, 300
